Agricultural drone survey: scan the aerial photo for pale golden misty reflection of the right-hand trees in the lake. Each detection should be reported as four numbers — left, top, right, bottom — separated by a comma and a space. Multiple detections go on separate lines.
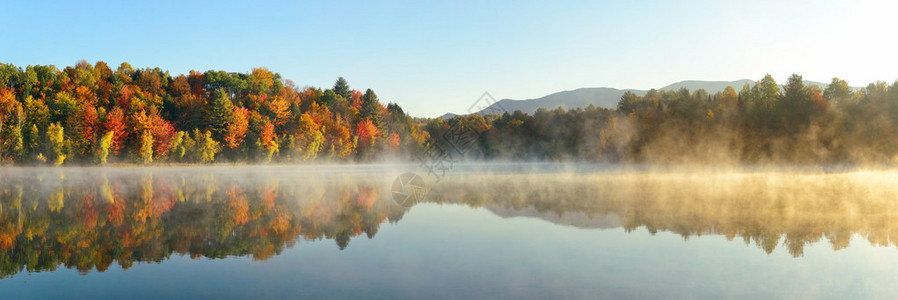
431, 172, 898, 257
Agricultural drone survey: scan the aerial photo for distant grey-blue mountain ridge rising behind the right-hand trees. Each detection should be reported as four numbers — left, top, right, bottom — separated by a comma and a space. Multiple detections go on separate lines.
440, 79, 844, 119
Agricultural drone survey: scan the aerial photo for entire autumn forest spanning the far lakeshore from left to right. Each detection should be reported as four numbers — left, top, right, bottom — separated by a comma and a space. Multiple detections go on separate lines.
0, 61, 898, 165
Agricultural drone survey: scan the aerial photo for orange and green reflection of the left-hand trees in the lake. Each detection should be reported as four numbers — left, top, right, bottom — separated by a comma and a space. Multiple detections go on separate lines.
0, 167, 405, 278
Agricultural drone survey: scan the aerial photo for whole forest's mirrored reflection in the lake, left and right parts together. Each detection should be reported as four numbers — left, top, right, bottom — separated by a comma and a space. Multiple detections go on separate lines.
0, 167, 898, 278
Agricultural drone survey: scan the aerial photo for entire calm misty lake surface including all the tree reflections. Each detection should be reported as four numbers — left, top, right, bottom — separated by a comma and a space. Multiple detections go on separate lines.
0, 164, 898, 299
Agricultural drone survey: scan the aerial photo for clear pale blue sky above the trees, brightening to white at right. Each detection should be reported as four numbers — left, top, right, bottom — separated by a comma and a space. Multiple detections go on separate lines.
0, 0, 898, 117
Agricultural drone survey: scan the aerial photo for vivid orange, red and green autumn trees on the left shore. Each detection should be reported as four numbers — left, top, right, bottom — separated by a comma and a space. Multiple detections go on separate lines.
0, 61, 427, 165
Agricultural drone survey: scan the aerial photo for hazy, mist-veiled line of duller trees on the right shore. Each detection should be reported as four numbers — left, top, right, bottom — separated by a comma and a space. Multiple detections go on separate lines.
432, 74, 898, 165
